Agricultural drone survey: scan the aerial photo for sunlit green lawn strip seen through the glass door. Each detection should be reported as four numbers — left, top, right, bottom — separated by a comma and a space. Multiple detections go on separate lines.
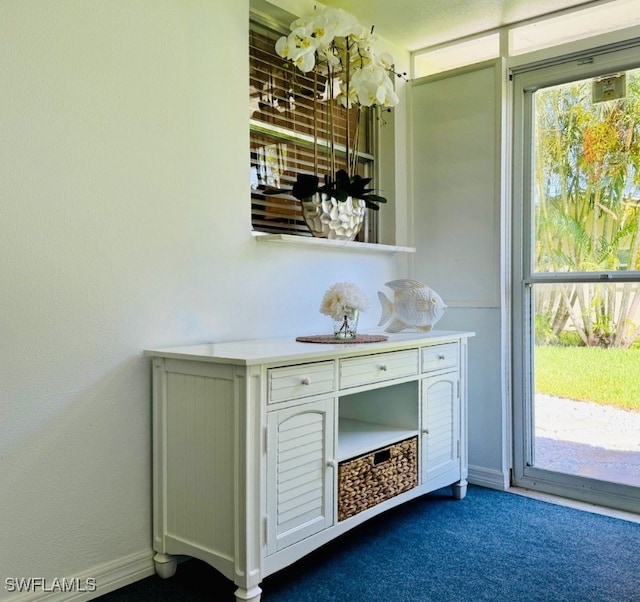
535, 345, 640, 410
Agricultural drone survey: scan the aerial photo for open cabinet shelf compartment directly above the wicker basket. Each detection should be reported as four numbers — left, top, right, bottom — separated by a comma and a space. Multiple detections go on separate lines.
338, 381, 420, 461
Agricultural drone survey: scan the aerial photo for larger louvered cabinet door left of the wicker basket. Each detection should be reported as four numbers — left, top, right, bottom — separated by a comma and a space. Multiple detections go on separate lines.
267, 398, 334, 554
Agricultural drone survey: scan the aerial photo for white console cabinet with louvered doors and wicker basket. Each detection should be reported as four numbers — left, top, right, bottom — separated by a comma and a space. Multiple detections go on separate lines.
145, 331, 473, 602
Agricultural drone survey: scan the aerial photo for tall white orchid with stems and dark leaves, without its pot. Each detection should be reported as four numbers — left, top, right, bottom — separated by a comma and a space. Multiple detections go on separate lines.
275, 7, 399, 210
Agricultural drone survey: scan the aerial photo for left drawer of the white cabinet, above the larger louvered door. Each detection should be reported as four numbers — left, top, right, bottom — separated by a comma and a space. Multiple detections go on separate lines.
267, 361, 335, 403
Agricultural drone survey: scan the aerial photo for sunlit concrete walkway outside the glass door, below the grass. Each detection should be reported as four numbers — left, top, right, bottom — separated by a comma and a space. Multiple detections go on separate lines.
535, 394, 640, 487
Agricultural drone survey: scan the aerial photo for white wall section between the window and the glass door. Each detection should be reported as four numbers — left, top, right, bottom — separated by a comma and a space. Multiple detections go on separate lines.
410, 62, 510, 488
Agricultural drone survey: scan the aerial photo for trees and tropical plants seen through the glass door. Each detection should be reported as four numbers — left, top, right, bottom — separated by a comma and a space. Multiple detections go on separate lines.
533, 71, 640, 348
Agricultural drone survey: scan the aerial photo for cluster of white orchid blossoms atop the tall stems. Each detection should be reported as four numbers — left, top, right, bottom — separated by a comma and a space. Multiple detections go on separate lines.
276, 7, 400, 108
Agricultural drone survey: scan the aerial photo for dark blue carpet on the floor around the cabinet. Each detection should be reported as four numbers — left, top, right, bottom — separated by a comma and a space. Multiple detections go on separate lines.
100, 486, 640, 602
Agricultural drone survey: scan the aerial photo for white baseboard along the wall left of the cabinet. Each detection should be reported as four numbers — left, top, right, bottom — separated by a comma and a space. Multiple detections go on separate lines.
0, 548, 155, 602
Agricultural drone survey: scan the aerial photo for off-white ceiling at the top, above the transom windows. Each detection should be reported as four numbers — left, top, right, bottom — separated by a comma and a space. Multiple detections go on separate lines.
322, 0, 610, 51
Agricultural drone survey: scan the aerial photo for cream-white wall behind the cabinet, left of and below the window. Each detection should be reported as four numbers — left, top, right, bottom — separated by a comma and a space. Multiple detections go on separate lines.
0, 0, 407, 600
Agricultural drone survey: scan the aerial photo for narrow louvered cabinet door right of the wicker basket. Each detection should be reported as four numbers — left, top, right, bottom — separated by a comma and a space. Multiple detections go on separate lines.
422, 371, 461, 484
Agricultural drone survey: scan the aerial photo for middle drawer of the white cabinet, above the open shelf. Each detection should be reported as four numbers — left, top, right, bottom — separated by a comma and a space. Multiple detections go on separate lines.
340, 349, 418, 389
